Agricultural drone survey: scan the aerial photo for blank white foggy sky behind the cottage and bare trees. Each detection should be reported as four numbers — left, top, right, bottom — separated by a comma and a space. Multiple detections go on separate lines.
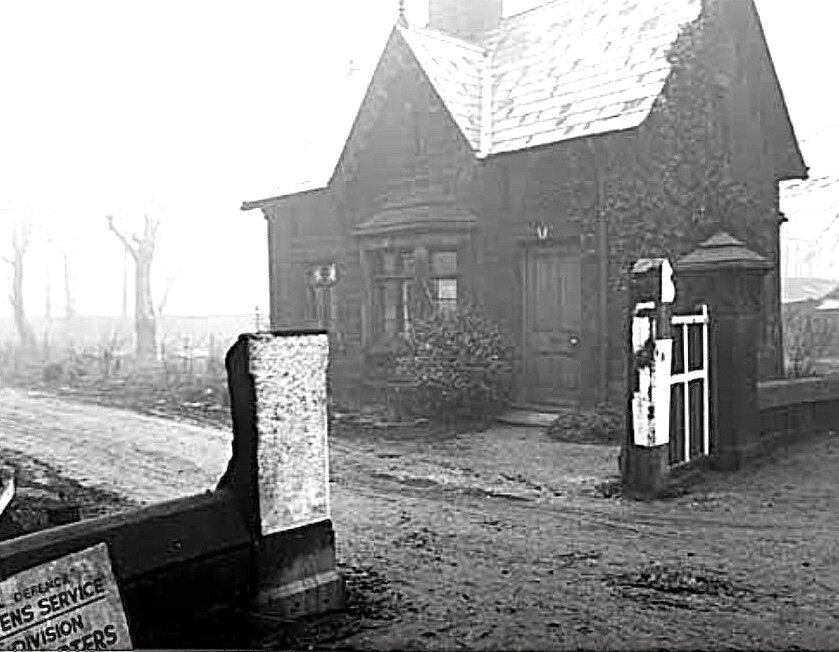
0, 0, 839, 317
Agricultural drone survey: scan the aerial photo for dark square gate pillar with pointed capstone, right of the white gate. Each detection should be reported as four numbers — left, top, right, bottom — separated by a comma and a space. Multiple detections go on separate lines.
676, 232, 772, 470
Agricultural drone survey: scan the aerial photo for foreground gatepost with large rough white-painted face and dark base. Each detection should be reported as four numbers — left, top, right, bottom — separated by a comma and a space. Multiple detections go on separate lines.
219, 331, 344, 619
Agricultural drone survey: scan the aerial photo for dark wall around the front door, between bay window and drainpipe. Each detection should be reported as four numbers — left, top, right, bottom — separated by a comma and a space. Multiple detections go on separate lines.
476, 141, 600, 404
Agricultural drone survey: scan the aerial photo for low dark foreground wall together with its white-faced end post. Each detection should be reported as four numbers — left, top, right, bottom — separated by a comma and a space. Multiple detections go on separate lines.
0, 331, 344, 648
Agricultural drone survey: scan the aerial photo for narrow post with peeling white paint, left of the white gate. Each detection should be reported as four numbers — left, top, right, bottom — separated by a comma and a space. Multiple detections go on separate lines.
621, 258, 675, 498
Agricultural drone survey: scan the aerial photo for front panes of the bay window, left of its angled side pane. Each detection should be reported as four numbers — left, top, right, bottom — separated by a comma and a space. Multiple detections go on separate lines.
374, 250, 416, 337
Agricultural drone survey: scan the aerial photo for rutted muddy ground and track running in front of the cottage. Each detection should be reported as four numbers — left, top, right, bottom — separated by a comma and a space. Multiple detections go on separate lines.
0, 389, 839, 649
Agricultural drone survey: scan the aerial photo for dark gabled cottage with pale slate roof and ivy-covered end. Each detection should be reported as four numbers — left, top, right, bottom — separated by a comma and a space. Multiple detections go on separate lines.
243, 0, 807, 404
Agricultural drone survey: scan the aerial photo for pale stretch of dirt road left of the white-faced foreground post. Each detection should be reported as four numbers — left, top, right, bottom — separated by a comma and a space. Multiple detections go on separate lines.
0, 388, 230, 504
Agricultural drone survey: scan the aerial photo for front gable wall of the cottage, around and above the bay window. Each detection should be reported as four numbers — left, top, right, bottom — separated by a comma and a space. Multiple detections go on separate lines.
264, 33, 478, 408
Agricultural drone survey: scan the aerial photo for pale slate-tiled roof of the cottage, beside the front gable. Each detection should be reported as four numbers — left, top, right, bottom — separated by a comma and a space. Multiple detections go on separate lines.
401, 0, 701, 155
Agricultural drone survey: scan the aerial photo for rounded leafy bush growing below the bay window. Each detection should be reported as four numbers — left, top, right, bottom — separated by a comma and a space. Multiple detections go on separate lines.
396, 308, 512, 421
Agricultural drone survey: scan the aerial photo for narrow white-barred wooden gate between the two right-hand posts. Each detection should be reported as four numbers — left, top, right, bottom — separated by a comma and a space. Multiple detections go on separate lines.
670, 306, 711, 465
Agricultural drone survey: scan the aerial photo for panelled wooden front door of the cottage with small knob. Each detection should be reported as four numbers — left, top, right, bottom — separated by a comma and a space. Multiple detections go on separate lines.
524, 248, 581, 403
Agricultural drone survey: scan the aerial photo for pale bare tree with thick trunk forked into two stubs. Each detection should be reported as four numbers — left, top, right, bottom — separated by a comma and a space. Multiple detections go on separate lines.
106, 215, 159, 360
